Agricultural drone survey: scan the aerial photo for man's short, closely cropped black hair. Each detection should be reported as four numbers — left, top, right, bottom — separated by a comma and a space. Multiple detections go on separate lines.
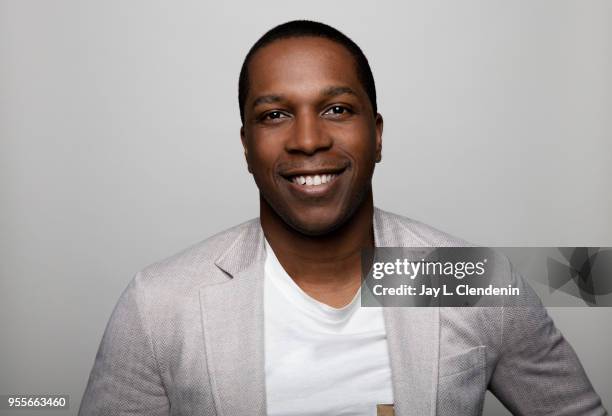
238, 20, 377, 123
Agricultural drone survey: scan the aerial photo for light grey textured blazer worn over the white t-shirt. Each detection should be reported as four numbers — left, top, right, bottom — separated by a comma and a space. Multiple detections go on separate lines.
79, 209, 606, 416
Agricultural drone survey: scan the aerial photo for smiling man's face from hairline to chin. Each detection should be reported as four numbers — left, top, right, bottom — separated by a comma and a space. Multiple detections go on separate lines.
241, 37, 382, 235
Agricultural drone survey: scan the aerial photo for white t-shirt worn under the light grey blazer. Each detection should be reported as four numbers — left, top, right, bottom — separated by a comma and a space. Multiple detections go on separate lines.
264, 241, 393, 416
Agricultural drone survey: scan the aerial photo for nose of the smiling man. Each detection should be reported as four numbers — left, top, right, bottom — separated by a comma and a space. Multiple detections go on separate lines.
285, 114, 333, 155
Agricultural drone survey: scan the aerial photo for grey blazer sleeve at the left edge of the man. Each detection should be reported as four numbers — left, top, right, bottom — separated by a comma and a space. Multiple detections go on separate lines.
79, 275, 170, 416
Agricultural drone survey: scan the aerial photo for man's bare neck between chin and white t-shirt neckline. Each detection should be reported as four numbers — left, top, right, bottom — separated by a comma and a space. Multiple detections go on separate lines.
260, 191, 374, 307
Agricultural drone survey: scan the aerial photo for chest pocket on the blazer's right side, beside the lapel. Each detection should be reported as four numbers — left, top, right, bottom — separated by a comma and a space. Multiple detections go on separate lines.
437, 345, 486, 416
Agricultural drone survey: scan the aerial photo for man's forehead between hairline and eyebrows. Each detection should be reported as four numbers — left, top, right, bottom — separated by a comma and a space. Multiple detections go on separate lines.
247, 37, 365, 101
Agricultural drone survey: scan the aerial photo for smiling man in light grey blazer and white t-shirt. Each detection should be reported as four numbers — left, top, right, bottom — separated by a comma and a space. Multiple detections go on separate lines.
80, 21, 605, 415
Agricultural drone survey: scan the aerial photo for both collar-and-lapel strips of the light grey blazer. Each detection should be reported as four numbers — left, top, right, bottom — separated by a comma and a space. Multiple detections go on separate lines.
200, 208, 439, 416
